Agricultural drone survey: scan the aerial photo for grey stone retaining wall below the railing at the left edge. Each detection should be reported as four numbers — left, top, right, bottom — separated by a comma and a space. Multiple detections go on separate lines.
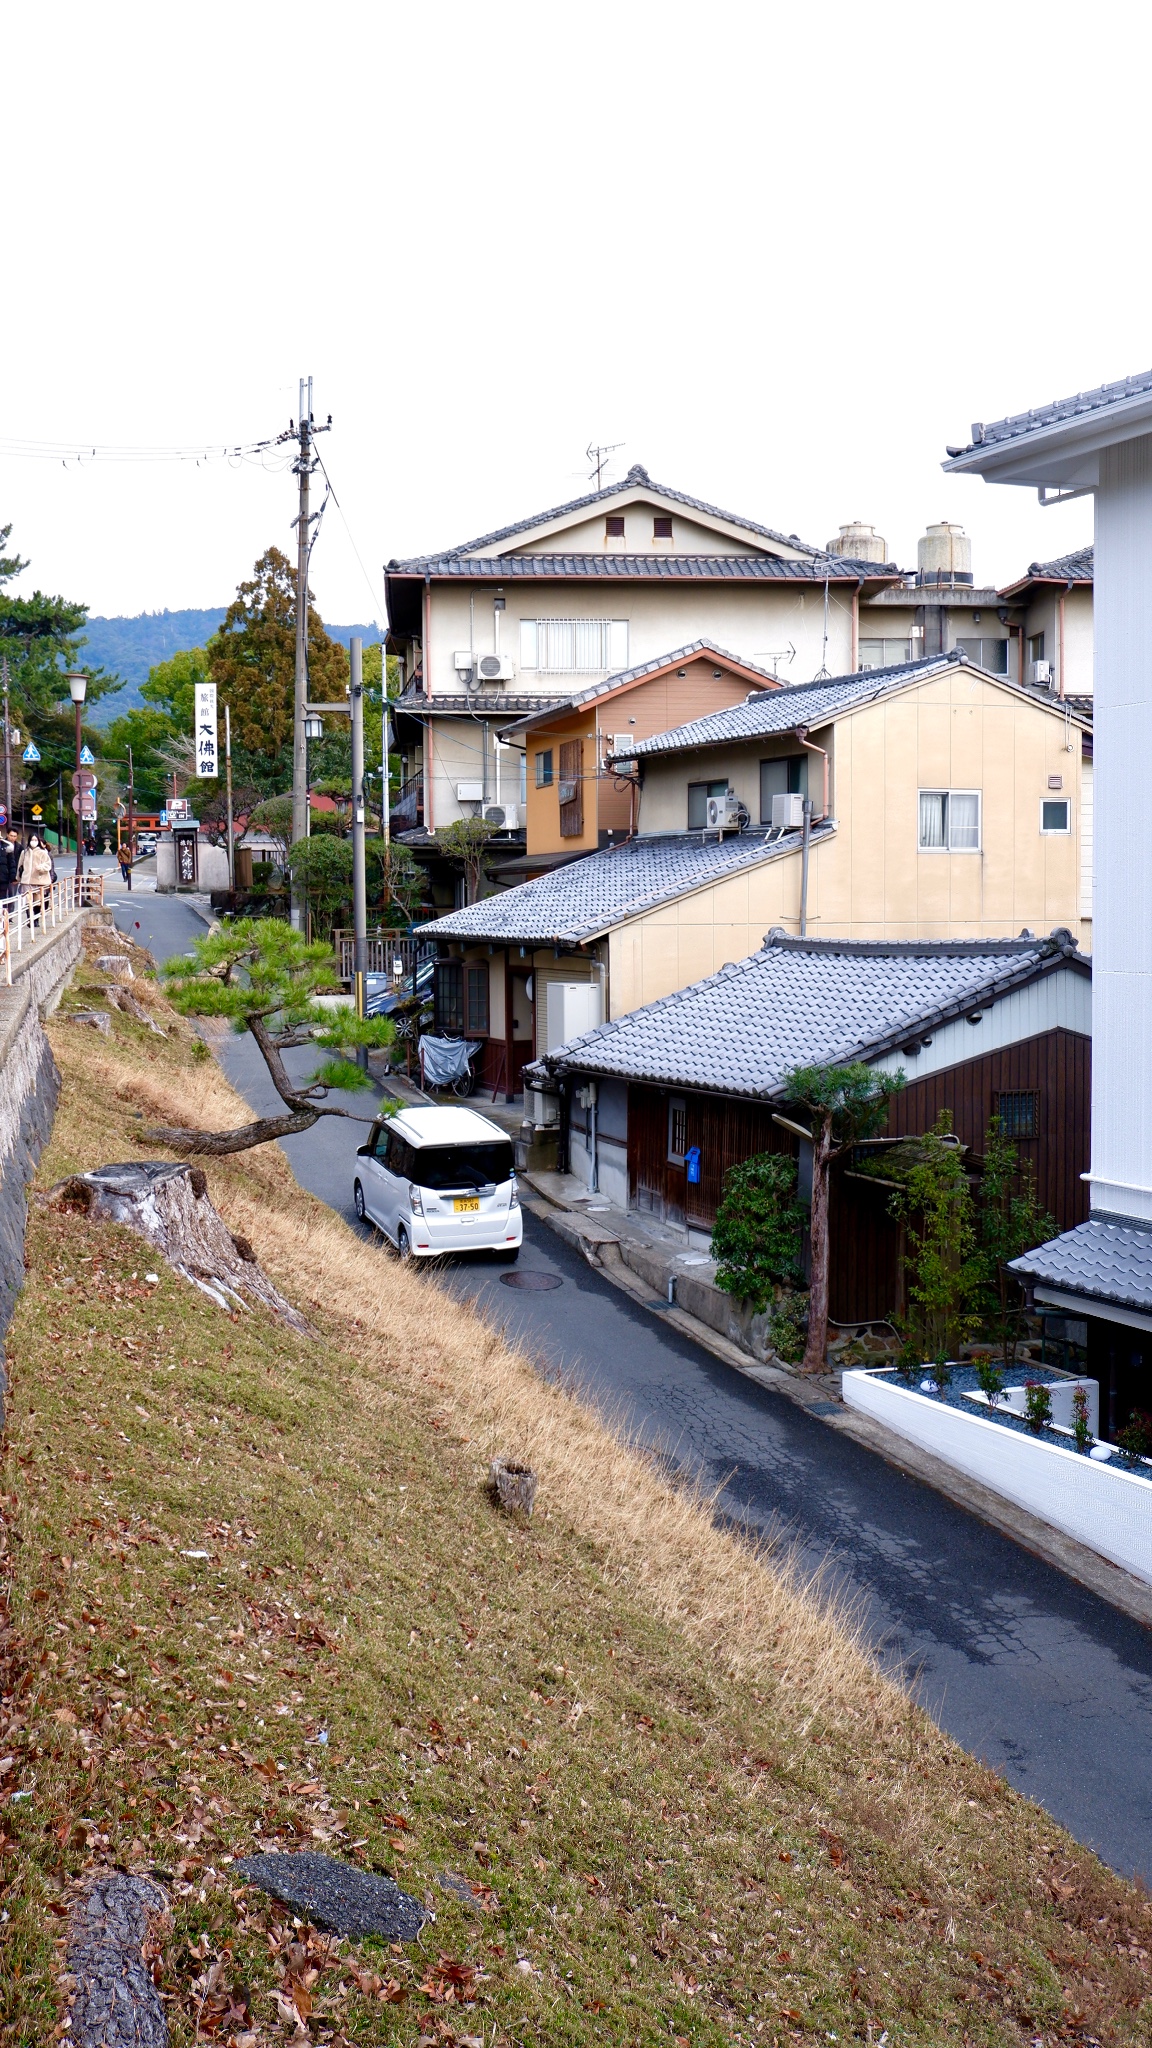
0, 911, 90, 1343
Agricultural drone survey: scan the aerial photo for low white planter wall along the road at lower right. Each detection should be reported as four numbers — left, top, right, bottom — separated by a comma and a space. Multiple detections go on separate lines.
840, 1370, 1152, 1585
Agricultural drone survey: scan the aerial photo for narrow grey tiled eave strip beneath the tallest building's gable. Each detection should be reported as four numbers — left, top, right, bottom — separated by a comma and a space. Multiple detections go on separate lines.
387, 553, 900, 584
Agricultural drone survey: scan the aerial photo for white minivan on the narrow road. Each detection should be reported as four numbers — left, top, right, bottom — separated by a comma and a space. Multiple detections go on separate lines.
353, 1108, 525, 1264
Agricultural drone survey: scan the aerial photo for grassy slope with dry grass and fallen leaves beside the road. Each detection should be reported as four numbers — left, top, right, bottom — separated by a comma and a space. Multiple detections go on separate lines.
0, 937, 1152, 2048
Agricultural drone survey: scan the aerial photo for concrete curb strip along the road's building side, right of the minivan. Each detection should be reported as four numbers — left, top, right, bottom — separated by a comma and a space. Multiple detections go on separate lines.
521, 1192, 1152, 1628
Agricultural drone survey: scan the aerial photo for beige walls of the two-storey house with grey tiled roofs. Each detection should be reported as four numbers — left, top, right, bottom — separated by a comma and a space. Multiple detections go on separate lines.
611, 670, 1082, 1016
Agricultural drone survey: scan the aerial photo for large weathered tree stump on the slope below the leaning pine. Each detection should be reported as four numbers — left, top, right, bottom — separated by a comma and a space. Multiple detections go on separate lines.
45, 1159, 307, 1335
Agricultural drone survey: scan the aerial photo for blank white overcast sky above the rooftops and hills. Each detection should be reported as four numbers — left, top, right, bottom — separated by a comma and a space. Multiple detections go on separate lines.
0, 0, 1131, 621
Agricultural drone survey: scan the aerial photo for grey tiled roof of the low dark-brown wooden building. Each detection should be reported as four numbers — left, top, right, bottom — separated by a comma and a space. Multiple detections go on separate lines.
537, 930, 1091, 1102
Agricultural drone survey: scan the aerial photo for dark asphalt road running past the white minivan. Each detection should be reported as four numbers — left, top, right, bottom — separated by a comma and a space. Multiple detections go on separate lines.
117, 897, 1152, 1880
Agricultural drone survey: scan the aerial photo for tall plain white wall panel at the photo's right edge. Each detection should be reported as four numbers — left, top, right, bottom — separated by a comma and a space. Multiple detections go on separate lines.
1088, 436, 1152, 1223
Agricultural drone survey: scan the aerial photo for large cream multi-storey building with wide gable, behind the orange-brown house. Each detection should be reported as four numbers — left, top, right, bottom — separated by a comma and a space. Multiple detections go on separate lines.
385, 467, 900, 834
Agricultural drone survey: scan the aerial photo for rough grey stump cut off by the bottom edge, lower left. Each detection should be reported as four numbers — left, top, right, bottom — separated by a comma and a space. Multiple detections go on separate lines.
64, 1870, 168, 2048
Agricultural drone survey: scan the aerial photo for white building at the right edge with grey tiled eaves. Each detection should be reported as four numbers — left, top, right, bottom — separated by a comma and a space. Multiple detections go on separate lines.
945, 371, 1152, 1434
